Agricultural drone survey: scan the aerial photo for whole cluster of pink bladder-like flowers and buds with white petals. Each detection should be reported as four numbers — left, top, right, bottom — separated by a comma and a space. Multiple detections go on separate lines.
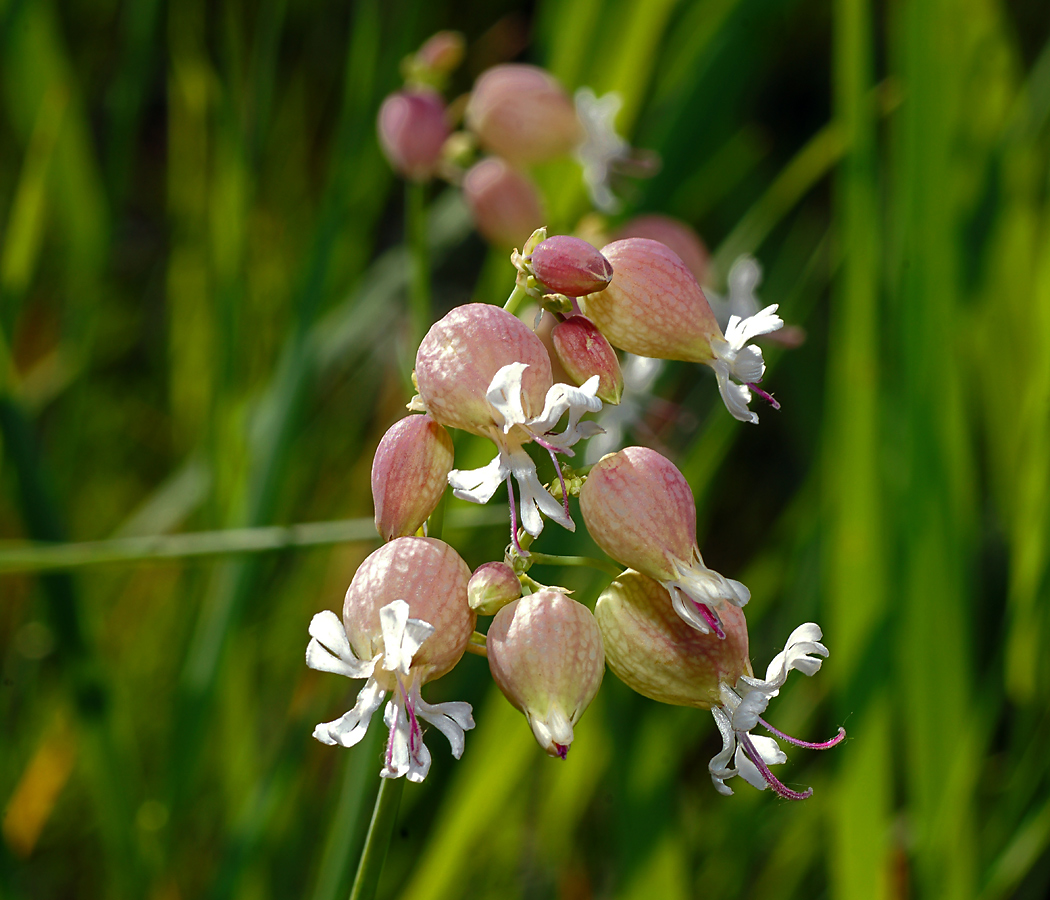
307, 35, 844, 799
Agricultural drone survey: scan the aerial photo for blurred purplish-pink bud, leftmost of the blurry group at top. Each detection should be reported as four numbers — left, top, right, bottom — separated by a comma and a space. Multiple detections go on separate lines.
376, 89, 449, 181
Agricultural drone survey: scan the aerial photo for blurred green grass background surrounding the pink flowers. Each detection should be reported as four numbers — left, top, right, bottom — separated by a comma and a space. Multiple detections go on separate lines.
0, 0, 1050, 900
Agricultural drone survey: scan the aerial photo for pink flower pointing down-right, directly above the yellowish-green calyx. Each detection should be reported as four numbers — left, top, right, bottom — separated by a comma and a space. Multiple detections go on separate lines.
580, 447, 751, 637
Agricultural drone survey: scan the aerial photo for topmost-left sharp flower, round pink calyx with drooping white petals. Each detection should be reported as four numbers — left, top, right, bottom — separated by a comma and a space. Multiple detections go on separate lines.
416, 304, 602, 554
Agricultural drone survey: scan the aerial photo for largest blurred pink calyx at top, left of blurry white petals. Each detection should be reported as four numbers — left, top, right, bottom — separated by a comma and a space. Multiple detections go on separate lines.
466, 63, 583, 166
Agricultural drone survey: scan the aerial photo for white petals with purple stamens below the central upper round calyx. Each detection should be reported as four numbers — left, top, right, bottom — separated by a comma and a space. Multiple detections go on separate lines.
448, 362, 602, 543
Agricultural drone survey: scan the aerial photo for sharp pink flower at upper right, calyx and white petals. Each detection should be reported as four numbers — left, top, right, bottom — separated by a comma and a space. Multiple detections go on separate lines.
583, 237, 783, 423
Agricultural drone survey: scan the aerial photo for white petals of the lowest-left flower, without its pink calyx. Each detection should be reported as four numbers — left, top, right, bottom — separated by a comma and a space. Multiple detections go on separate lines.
307, 600, 474, 781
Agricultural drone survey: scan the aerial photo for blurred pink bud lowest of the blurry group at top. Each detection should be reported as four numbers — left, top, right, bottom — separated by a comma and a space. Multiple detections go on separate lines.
463, 156, 544, 248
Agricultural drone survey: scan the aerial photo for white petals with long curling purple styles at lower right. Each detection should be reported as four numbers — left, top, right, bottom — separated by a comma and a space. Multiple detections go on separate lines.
708, 622, 845, 800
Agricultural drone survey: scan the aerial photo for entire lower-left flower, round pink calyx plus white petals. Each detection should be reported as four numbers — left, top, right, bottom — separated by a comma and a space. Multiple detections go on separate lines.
307, 538, 477, 781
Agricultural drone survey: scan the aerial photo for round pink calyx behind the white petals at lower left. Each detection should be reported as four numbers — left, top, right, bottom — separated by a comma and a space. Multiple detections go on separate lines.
342, 538, 478, 690
